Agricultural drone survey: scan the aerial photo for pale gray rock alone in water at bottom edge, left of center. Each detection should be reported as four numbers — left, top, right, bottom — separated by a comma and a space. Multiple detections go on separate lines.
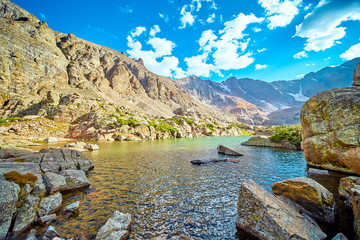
96, 211, 131, 240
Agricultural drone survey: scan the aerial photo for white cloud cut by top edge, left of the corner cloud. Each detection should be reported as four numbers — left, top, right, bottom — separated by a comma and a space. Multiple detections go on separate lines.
258, 0, 302, 29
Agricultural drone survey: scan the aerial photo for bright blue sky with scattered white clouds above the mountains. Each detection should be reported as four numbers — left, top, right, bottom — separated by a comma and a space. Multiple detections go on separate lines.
13, 0, 360, 81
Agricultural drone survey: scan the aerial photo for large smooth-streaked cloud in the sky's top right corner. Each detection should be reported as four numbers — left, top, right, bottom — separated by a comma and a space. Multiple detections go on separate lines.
296, 0, 360, 52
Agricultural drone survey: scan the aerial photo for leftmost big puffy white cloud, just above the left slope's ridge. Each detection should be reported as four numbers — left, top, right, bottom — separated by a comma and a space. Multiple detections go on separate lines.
127, 25, 185, 78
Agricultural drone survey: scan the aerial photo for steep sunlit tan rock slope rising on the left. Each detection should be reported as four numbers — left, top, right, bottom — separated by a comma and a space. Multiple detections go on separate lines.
0, 0, 225, 122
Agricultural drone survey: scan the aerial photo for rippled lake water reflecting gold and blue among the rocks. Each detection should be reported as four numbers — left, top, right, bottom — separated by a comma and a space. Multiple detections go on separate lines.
55, 137, 352, 239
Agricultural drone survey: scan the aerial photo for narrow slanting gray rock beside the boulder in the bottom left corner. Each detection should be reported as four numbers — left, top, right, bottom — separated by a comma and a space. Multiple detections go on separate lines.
13, 195, 40, 236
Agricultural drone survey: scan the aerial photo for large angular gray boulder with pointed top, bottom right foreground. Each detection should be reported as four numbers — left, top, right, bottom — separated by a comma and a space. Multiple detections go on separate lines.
236, 180, 326, 240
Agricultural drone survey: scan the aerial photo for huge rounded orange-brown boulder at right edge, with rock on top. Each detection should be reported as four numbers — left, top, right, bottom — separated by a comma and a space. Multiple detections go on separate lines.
300, 64, 360, 174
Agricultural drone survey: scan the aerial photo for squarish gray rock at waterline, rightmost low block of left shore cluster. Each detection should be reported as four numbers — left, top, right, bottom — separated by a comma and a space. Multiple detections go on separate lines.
60, 170, 90, 190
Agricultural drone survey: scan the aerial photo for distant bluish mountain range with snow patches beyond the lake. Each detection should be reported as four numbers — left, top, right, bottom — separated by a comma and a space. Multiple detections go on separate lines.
177, 58, 360, 125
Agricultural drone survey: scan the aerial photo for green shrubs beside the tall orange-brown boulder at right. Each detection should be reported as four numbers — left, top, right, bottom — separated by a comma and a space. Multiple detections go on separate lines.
270, 125, 302, 149
